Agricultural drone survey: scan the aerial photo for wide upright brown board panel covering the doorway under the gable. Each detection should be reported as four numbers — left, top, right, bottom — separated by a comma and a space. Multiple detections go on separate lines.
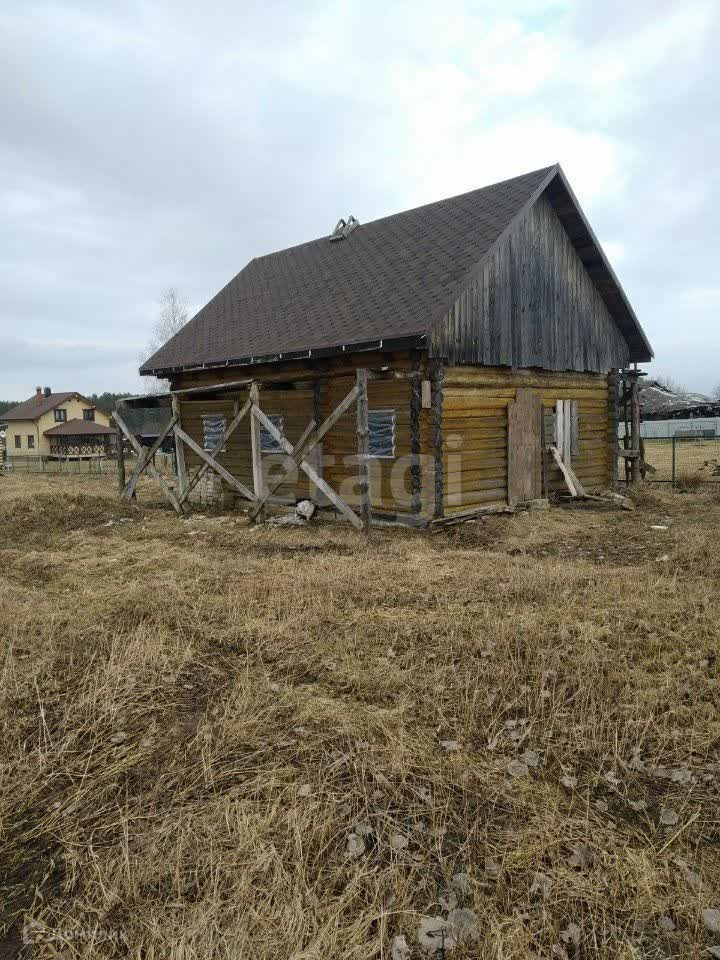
507, 387, 542, 506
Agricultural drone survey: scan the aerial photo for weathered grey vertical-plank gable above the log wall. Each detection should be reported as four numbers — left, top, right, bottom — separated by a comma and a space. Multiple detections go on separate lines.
428, 195, 630, 373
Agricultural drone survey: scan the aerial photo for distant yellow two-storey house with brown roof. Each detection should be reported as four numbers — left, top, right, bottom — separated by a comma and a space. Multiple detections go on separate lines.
3, 387, 115, 462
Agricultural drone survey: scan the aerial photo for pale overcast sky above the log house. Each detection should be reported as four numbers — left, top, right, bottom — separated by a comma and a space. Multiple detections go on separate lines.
0, 0, 720, 400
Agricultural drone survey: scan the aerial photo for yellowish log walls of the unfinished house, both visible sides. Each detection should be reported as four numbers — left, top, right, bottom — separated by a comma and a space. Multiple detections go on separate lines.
173, 354, 614, 519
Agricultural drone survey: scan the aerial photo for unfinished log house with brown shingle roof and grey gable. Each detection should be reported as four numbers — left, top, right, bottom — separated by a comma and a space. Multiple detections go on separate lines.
136, 166, 653, 523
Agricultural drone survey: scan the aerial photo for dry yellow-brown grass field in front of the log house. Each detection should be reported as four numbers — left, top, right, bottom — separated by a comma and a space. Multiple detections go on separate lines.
0, 476, 720, 960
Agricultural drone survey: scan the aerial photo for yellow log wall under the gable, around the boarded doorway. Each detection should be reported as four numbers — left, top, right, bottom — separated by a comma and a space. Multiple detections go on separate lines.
442, 366, 616, 515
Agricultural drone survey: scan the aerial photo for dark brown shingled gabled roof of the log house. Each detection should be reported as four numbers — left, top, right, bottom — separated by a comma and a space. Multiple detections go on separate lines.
140, 165, 652, 375
